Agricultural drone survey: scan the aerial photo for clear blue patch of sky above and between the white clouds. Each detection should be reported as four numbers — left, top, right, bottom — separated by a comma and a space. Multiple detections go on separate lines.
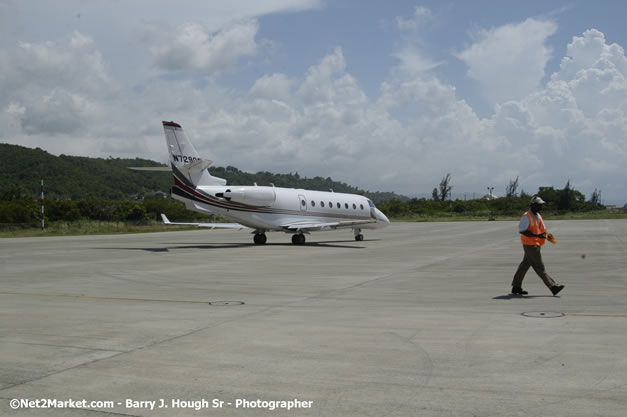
250, 0, 627, 117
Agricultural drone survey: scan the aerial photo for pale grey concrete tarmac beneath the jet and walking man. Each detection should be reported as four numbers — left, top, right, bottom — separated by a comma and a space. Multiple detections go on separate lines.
0, 218, 627, 417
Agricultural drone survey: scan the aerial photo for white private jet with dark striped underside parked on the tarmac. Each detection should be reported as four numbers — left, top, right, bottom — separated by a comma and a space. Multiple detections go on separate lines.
154, 122, 390, 245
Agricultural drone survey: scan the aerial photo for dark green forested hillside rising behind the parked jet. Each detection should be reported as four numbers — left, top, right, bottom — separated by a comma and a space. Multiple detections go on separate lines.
0, 143, 407, 202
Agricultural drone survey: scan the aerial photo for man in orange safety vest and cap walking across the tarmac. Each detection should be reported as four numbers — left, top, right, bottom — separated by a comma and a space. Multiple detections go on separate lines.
512, 196, 564, 295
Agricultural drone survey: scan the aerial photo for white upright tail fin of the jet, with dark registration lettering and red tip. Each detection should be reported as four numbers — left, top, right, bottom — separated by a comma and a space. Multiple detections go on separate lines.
163, 121, 226, 187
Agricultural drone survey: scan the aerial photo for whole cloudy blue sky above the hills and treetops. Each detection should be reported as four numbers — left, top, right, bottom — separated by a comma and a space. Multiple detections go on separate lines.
0, 0, 627, 203
